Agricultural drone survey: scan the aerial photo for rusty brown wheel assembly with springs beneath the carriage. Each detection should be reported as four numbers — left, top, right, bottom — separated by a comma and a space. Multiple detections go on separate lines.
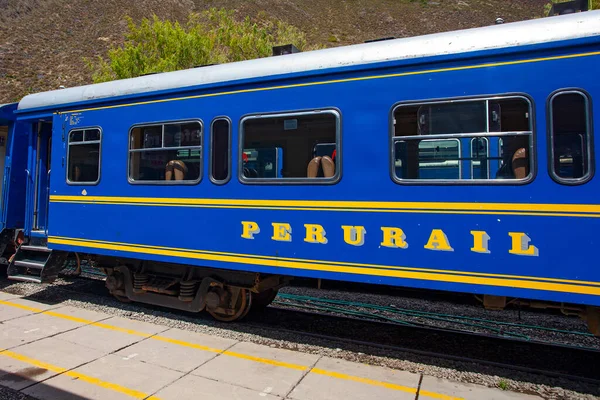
101, 257, 291, 322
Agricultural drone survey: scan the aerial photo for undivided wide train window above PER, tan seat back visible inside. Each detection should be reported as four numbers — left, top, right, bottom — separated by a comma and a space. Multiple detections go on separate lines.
239, 110, 341, 184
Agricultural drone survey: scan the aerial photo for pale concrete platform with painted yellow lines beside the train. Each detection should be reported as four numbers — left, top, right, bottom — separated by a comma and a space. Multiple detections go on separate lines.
0, 292, 538, 400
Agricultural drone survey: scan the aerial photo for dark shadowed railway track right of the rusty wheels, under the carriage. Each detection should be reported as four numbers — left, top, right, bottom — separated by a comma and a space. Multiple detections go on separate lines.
250, 306, 600, 385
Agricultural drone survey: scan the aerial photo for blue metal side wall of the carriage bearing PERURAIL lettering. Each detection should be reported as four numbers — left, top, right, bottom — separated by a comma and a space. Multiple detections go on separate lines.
38, 37, 600, 305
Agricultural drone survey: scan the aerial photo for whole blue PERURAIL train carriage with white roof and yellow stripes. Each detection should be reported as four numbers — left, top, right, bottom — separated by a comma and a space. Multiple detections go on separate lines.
7, 11, 600, 334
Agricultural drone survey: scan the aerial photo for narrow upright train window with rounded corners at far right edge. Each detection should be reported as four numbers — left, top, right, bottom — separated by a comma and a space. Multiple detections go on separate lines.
549, 90, 593, 184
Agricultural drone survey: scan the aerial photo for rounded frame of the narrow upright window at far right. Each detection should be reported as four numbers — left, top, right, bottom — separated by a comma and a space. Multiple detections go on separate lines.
546, 87, 596, 186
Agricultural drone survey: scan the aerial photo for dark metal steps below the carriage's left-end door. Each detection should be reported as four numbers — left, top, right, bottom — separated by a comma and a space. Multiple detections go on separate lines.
8, 245, 67, 283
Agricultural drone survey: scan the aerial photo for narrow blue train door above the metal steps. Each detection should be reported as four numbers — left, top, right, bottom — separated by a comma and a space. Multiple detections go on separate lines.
25, 121, 52, 237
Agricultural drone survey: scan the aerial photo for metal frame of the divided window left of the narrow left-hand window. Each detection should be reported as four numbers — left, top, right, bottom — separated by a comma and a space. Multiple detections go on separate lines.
127, 118, 205, 186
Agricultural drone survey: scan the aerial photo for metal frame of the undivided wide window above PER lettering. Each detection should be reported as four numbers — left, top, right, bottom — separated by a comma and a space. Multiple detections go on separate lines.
237, 107, 343, 186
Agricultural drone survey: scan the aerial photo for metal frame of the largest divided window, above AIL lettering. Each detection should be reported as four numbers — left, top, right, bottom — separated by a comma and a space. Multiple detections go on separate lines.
388, 92, 537, 186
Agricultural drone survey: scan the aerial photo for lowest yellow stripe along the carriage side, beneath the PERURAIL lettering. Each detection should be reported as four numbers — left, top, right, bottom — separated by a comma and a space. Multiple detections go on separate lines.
48, 236, 600, 296
